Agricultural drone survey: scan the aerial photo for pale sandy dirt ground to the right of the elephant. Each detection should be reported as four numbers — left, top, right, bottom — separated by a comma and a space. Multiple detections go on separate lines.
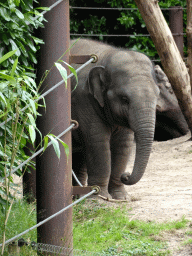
13, 134, 192, 256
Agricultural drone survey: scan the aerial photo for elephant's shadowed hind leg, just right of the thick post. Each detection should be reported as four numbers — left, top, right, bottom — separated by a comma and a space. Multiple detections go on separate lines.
72, 152, 87, 186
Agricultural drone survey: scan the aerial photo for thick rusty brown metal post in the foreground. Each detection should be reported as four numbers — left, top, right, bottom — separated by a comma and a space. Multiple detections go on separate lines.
36, 0, 72, 255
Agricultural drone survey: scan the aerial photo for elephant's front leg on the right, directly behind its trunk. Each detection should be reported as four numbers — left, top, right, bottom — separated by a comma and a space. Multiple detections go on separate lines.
108, 127, 134, 200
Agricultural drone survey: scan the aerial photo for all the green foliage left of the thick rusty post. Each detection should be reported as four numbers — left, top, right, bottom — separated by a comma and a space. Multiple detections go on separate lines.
0, 0, 47, 210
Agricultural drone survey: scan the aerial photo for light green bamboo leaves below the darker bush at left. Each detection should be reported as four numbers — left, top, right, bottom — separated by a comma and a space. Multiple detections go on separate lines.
0, 50, 42, 210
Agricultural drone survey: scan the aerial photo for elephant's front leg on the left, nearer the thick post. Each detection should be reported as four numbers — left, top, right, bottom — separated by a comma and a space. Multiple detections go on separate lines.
85, 123, 111, 198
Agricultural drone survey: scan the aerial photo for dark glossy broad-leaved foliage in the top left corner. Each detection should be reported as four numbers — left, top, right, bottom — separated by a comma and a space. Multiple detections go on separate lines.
0, 0, 45, 76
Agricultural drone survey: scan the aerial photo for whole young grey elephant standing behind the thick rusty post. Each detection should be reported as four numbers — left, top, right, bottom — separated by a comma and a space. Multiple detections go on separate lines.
71, 39, 159, 199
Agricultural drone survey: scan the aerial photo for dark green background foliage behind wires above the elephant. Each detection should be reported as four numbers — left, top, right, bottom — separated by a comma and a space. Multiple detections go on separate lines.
70, 0, 187, 62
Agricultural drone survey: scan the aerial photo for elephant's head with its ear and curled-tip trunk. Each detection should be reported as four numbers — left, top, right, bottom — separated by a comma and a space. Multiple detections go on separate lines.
87, 51, 159, 185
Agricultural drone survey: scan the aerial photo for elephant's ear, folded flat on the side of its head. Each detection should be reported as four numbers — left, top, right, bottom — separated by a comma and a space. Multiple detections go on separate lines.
88, 66, 105, 107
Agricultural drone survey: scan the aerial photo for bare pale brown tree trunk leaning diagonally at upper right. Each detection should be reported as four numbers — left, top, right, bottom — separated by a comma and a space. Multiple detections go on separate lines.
135, 0, 192, 136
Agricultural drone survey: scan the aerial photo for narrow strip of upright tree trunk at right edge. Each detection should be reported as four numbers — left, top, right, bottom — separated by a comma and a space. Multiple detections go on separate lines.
186, 0, 192, 88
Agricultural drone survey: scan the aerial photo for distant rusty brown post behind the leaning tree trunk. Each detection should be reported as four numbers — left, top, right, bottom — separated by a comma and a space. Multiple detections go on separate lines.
169, 6, 184, 58
